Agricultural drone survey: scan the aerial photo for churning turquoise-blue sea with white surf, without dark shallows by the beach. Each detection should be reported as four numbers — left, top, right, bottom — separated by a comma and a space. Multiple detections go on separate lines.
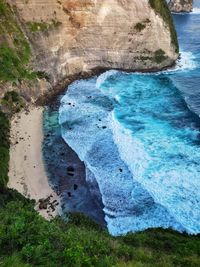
59, 7, 200, 235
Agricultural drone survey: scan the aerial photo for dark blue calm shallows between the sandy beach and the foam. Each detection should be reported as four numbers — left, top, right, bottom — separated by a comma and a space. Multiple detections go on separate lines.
43, 95, 105, 226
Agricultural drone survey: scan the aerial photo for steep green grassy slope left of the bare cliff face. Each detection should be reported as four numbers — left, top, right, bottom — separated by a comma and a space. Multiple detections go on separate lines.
0, 0, 37, 83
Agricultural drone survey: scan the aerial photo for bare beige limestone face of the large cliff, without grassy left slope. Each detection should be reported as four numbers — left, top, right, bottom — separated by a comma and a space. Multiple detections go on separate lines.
1, 0, 178, 100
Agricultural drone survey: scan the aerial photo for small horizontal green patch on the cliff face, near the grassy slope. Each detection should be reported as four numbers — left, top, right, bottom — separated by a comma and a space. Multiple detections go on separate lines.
26, 20, 62, 33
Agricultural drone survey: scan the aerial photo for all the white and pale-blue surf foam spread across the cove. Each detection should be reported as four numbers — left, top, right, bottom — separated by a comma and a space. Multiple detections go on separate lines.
59, 71, 200, 235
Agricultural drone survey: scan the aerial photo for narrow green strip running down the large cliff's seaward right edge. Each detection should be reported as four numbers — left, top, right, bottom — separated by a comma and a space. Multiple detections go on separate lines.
149, 0, 179, 53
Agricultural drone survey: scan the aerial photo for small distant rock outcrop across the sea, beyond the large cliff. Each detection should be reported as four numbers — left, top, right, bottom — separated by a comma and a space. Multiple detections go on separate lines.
169, 0, 193, 13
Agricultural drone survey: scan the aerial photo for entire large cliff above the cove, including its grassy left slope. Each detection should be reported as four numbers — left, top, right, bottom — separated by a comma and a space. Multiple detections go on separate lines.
0, 0, 178, 100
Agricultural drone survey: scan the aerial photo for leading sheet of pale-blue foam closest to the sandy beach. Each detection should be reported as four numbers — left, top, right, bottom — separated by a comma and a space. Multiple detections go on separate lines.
60, 76, 192, 235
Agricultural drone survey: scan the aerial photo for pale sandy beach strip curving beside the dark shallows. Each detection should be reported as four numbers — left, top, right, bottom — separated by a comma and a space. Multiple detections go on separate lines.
8, 107, 60, 219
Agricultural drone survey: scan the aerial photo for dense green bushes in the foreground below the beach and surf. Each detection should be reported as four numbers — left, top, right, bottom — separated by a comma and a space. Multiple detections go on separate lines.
0, 189, 200, 267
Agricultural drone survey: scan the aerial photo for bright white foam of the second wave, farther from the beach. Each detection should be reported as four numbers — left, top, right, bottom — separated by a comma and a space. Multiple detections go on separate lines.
108, 101, 200, 234
